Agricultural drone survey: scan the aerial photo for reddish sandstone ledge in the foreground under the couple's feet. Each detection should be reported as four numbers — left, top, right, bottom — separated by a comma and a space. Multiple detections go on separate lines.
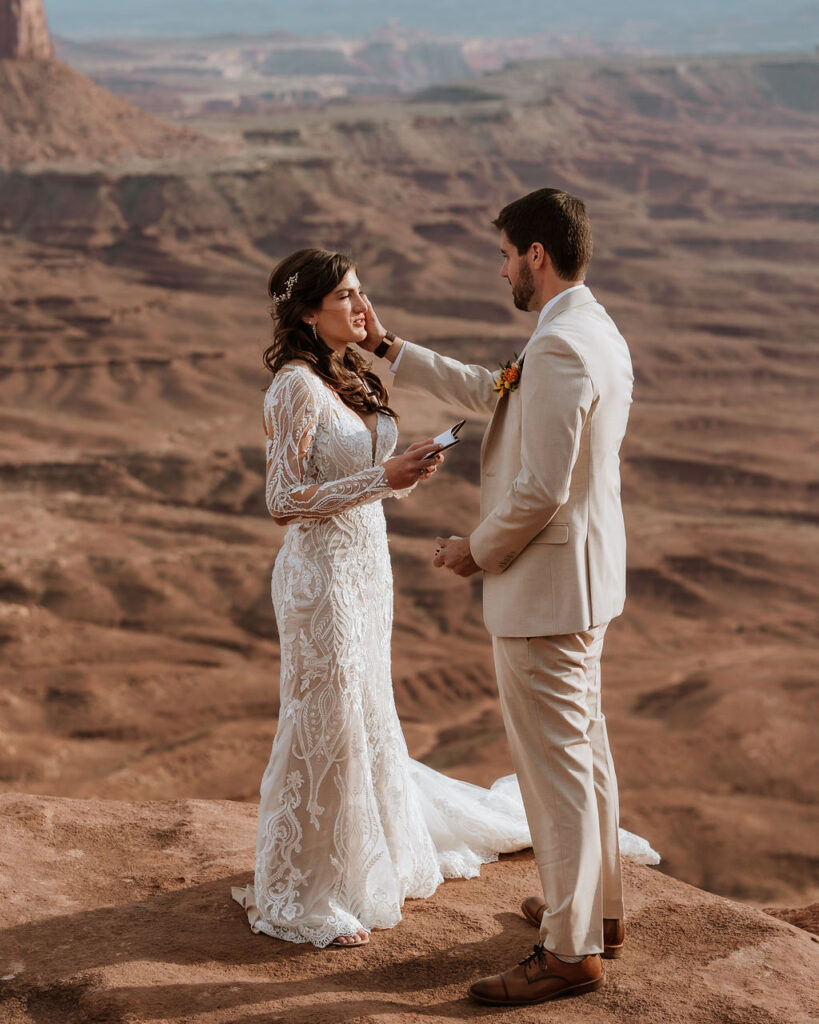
0, 794, 819, 1024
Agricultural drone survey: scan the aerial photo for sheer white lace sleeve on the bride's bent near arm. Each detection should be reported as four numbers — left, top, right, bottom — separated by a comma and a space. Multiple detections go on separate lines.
264, 370, 392, 521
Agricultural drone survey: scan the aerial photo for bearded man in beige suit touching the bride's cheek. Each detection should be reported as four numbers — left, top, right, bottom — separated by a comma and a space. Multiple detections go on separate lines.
365, 188, 633, 1006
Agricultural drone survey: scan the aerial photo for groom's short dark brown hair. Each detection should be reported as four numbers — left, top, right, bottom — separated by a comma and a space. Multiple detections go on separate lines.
492, 188, 592, 281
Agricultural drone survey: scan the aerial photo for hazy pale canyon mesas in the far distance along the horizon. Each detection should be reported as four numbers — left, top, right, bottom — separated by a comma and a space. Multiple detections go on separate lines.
51, 23, 610, 117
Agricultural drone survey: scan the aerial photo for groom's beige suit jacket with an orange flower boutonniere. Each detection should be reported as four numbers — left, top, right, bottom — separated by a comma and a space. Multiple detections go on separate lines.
395, 288, 634, 637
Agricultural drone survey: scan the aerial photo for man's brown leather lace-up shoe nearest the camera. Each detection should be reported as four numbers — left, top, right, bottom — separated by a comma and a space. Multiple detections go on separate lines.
469, 946, 603, 1007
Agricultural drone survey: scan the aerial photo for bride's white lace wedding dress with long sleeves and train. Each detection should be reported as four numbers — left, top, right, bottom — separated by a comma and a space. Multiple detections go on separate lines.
232, 362, 658, 946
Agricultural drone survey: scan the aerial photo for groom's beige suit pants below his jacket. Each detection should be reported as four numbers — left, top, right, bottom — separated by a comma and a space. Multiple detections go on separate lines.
492, 625, 624, 956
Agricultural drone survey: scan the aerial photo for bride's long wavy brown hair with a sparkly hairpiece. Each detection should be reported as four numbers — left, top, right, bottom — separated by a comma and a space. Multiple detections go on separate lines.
264, 249, 398, 420
